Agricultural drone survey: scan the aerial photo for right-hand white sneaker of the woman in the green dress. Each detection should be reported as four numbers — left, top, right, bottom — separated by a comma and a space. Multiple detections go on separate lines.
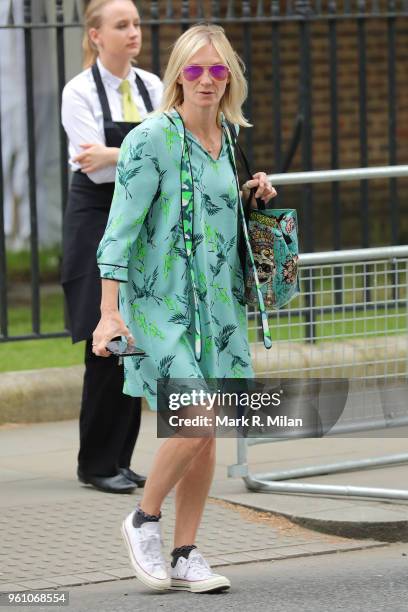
170, 549, 231, 593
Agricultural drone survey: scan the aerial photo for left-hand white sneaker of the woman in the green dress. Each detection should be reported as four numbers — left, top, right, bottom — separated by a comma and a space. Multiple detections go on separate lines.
122, 512, 171, 591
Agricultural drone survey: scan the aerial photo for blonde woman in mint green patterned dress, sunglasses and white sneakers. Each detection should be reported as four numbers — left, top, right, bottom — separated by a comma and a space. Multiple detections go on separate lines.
93, 25, 276, 592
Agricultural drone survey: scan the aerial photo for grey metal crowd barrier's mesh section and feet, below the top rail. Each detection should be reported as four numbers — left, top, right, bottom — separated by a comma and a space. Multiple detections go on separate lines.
229, 246, 408, 499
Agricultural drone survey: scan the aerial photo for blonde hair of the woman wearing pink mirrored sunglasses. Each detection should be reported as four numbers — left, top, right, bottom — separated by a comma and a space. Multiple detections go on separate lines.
159, 24, 251, 127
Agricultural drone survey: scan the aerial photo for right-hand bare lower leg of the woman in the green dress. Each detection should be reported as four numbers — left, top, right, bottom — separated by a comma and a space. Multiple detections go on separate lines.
174, 438, 215, 548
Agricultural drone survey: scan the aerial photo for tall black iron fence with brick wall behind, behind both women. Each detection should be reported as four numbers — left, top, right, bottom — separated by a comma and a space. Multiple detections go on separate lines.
0, 0, 408, 341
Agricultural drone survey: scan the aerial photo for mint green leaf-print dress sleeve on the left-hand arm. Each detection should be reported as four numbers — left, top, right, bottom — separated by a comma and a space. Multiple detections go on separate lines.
96, 126, 160, 282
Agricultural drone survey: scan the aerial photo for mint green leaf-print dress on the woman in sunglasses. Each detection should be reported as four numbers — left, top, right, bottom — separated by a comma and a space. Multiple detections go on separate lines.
97, 114, 253, 410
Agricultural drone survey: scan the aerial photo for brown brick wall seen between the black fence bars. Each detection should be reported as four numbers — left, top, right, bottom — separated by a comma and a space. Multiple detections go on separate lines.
136, 3, 408, 250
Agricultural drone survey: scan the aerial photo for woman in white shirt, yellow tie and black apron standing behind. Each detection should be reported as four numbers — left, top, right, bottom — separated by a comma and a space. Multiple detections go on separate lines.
62, 0, 162, 493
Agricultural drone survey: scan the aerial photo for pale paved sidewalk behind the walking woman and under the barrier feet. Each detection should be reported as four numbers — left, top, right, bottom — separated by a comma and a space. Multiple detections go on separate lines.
0, 412, 407, 590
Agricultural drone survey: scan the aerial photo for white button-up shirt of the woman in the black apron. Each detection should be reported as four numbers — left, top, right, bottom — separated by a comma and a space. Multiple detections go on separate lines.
61, 58, 163, 183
